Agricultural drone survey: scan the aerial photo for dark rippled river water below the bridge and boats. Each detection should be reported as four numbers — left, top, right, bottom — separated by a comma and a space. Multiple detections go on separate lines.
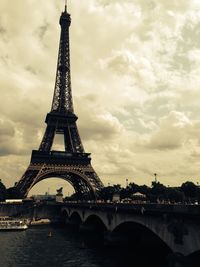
0, 225, 168, 267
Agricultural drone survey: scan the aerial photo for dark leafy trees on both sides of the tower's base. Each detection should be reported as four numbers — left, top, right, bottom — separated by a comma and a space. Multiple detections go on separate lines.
0, 180, 200, 203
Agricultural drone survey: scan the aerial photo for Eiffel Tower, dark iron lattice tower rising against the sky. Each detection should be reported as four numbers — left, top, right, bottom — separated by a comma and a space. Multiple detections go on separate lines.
14, 3, 103, 199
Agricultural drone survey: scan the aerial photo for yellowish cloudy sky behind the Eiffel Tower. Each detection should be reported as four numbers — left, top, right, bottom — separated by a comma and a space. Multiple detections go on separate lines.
0, 0, 200, 196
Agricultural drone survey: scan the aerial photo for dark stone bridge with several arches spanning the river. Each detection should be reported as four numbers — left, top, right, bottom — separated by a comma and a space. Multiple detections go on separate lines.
61, 202, 200, 266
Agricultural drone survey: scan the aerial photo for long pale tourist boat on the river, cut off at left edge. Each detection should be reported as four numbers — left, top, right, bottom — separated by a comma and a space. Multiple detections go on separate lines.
0, 217, 28, 231
